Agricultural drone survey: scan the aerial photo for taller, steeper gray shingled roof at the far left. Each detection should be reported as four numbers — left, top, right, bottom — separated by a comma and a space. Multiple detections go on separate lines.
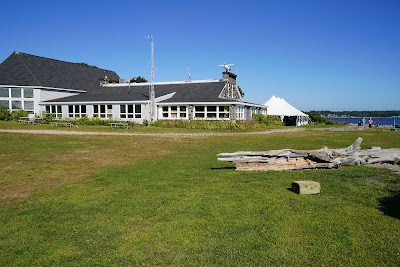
0, 52, 119, 91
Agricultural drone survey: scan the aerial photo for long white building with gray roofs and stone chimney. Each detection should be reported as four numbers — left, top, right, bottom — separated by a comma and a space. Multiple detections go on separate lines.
0, 52, 267, 123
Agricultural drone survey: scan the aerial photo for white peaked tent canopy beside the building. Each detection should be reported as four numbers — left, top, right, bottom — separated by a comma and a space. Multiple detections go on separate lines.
264, 95, 310, 126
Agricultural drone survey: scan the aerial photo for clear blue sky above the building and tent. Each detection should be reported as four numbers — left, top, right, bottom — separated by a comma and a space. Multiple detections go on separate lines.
0, 0, 400, 111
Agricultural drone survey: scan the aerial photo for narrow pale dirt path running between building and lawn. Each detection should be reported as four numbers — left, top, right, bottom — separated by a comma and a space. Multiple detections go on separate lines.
0, 128, 304, 137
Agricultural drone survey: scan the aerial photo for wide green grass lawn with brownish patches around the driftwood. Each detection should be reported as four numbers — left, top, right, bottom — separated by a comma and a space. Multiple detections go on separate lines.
0, 124, 400, 266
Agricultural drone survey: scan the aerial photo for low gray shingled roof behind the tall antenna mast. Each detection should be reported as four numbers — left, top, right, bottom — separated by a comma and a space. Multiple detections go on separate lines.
48, 81, 238, 103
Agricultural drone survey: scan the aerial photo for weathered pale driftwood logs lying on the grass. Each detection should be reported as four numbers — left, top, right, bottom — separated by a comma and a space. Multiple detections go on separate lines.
218, 137, 400, 171
